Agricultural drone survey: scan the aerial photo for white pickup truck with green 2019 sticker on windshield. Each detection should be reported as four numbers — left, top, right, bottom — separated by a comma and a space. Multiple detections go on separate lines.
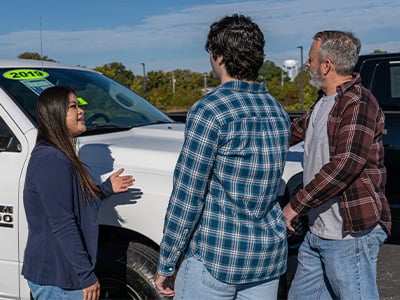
0, 60, 302, 300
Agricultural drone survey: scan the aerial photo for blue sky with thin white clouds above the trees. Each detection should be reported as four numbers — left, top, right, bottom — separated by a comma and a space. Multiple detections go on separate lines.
0, 0, 400, 75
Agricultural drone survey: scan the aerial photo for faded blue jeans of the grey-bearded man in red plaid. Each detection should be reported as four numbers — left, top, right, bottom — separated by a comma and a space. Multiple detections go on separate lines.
288, 226, 387, 300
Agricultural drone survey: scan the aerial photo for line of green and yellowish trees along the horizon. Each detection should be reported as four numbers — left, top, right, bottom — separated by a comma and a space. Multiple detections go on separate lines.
18, 50, 384, 112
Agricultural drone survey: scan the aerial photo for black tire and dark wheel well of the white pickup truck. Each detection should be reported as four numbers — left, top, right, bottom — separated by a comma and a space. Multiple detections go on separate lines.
96, 242, 164, 300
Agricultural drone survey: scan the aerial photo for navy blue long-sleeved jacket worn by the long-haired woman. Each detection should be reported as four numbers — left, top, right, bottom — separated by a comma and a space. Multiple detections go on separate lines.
22, 143, 112, 289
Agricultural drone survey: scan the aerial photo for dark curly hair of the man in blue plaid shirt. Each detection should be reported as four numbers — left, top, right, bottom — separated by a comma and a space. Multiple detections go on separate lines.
205, 14, 265, 81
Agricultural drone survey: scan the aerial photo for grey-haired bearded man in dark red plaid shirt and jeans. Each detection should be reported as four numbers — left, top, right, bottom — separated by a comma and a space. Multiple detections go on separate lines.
283, 31, 391, 300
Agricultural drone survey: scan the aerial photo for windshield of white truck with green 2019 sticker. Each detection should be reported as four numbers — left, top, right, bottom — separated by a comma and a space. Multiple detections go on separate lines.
0, 68, 173, 134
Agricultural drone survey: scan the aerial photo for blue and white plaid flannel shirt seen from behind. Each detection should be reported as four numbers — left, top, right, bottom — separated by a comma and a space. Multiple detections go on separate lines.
158, 80, 290, 284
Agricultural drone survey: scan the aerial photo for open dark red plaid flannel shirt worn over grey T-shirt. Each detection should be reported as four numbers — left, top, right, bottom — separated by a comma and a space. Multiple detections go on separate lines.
290, 73, 391, 234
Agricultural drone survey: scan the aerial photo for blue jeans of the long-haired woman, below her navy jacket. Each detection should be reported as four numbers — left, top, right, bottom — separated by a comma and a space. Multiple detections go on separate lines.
28, 281, 83, 300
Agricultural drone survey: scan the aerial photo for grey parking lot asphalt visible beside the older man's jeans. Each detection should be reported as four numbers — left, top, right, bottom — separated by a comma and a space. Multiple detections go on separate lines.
280, 244, 400, 300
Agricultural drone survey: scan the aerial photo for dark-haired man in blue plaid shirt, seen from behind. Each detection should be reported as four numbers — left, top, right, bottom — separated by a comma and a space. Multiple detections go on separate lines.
155, 15, 290, 300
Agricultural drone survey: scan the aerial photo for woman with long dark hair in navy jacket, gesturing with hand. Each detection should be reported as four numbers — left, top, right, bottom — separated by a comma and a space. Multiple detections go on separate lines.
22, 86, 134, 300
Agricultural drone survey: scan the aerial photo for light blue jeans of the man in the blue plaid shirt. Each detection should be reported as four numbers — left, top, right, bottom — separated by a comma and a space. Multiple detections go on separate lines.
174, 258, 279, 300
